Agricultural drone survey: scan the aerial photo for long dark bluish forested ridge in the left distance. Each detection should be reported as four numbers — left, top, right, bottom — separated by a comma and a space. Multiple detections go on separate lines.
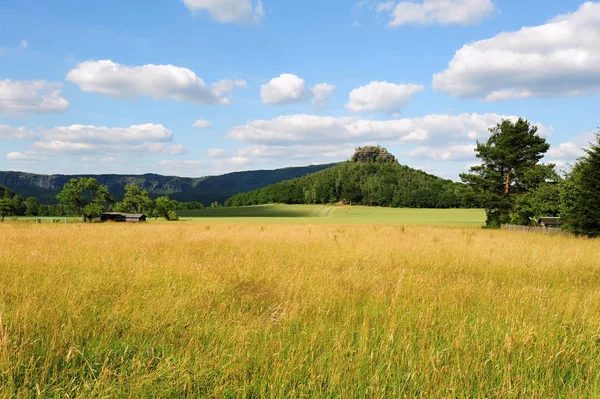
0, 164, 335, 205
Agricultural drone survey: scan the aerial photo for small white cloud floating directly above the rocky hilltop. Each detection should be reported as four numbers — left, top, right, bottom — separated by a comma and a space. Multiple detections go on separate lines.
346, 81, 424, 112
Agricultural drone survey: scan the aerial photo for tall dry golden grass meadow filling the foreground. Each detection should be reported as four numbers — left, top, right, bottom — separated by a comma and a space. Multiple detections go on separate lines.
0, 223, 600, 398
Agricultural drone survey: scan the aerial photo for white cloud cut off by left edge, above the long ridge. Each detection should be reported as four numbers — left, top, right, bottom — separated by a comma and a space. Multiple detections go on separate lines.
0, 79, 69, 116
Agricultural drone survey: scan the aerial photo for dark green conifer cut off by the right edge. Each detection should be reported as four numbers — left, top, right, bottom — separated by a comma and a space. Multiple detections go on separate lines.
561, 132, 600, 237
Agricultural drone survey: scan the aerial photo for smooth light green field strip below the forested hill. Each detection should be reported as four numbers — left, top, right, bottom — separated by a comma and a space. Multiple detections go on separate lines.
178, 205, 485, 227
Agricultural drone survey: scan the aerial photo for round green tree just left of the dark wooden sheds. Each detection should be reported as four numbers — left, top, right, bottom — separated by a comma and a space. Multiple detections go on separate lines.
56, 177, 114, 222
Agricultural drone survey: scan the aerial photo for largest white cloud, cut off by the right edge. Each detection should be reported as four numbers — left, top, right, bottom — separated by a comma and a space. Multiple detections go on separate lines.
433, 2, 600, 101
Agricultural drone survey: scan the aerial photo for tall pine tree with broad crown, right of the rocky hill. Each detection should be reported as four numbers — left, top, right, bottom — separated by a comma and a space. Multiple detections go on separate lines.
461, 118, 554, 228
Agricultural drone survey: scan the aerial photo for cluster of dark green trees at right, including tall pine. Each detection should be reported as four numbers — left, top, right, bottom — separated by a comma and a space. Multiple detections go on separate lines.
461, 119, 600, 237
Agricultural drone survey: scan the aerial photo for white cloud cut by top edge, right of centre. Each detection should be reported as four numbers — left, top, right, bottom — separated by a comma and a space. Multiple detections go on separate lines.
382, 0, 495, 26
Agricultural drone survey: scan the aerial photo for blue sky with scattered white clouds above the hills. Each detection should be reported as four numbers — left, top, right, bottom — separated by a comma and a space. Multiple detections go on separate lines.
0, 0, 600, 179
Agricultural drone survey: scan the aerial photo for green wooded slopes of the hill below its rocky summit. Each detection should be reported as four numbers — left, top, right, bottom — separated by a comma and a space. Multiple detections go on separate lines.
226, 161, 469, 208
